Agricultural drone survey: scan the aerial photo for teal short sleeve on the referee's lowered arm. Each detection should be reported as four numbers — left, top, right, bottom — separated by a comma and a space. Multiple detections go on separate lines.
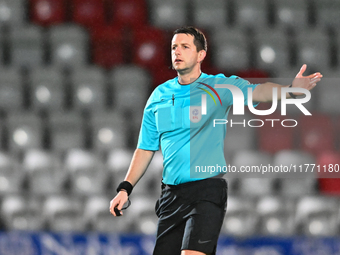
137, 101, 159, 151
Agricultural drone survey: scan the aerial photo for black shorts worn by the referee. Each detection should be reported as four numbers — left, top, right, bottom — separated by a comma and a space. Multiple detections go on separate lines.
153, 178, 228, 255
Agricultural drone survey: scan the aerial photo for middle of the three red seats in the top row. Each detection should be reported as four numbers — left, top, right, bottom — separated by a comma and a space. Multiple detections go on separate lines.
72, 0, 105, 28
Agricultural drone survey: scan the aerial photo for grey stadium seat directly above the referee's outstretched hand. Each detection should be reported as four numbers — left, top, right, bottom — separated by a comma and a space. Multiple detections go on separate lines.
296, 28, 331, 71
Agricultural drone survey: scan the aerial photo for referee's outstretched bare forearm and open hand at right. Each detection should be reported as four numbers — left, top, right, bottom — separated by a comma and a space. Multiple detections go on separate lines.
252, 64, 322, 102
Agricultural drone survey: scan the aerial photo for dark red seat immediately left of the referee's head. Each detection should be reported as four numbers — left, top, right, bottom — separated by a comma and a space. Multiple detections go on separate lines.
132, 27, 170, 70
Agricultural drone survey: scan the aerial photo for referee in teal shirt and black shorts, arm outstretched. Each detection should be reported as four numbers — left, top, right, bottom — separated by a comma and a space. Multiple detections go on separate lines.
110, 27, 322, 255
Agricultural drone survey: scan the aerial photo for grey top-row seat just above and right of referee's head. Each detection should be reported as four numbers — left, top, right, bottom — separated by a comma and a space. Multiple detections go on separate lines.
192, 0, 230, 29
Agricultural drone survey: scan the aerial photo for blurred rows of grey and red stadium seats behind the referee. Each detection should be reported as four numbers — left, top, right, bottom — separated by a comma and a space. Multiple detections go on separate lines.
0, 0, 340, 254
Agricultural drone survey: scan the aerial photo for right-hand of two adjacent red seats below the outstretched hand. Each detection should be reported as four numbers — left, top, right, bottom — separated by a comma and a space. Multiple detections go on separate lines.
298, 114, 335, 154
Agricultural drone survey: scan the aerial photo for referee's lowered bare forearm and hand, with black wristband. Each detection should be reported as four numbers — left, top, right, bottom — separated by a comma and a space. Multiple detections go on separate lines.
110, 148, 155, 216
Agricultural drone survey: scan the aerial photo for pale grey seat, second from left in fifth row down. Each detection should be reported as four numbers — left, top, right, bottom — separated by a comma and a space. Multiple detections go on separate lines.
22, 149, 67, 197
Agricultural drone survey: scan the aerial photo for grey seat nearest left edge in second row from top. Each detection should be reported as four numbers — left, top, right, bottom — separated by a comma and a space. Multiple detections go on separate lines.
8, 25, 45, 68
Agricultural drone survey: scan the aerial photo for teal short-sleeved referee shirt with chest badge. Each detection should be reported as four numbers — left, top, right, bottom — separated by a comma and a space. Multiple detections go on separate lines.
137, 73, 258, 185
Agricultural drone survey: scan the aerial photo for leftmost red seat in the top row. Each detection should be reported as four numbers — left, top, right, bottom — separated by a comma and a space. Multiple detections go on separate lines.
31, 0, 66, 26
